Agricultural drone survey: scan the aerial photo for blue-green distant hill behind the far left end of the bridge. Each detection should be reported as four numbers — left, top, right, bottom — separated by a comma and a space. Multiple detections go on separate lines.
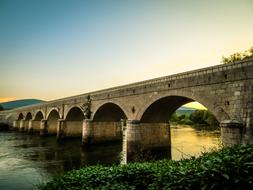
0, 99, 45, 110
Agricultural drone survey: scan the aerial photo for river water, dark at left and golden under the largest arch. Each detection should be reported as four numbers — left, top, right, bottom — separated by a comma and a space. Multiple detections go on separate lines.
0, 126, 220, 190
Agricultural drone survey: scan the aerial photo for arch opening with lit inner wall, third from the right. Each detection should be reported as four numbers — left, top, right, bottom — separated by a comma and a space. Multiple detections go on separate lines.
63, 107, 85, 137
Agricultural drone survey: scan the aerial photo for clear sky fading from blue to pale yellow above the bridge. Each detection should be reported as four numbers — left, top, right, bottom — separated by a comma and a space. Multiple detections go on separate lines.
0, 0, 253, 105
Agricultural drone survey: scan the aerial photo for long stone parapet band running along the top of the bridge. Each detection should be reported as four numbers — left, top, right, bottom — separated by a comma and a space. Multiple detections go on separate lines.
3, 58, 253, 112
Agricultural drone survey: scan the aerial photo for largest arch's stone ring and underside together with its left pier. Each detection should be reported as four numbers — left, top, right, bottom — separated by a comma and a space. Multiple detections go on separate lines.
127, 90, 228, 162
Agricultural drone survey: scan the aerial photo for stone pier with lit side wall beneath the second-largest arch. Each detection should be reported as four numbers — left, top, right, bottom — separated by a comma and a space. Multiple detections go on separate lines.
82, 119, 122, 145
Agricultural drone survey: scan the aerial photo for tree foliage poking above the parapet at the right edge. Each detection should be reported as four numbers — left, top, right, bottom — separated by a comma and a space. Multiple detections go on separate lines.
221, 47, 253, 64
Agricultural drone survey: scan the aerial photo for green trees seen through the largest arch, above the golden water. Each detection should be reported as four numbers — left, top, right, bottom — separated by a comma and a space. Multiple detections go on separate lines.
170, 110, 219, 130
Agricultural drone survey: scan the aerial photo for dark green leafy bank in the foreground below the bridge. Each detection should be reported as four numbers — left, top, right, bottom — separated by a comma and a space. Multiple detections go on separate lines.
38, 145, 253, 190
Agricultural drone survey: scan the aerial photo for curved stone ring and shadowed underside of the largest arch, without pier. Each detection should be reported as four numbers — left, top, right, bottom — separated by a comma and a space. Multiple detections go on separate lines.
137, 91, 229, 122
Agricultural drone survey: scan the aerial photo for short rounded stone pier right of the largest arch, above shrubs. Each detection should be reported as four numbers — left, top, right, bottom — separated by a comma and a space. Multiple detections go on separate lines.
220, 120, 243, 146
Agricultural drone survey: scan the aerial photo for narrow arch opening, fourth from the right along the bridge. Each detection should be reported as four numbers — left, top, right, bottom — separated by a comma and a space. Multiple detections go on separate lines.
46, 109, 60, 135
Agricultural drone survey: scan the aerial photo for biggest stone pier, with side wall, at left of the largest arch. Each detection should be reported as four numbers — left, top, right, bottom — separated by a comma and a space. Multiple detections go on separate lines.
123, 120, 171, 162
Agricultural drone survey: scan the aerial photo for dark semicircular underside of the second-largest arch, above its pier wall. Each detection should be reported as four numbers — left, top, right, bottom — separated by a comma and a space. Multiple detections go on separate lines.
93, 103, 127, 122
